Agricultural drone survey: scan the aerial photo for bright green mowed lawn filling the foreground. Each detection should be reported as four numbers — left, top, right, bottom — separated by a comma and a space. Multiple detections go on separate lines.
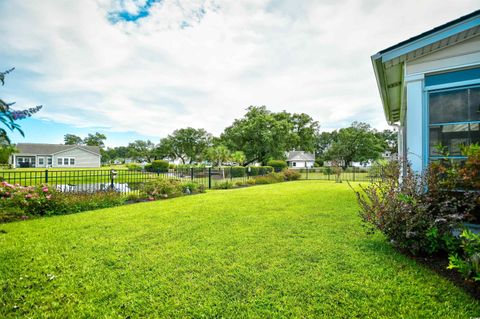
0, 181, 480, 318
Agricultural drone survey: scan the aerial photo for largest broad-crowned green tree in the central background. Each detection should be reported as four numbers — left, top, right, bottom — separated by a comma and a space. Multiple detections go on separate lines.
221, 106, 318, 164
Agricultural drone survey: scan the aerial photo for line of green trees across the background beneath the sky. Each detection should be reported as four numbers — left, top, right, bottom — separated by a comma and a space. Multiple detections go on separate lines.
64, 106, 397, 166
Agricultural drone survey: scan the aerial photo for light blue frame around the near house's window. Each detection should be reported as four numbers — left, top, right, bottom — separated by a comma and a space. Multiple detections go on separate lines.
423, 79, 480, 167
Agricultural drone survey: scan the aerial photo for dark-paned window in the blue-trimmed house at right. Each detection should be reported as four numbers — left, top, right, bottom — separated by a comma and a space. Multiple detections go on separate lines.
428, 86, 480, 159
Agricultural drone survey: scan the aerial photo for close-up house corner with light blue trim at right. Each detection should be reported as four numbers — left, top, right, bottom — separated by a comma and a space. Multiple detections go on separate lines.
371, 10, 480, 172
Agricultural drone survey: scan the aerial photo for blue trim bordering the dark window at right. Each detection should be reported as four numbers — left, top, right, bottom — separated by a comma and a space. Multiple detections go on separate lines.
422, 79, 480, 169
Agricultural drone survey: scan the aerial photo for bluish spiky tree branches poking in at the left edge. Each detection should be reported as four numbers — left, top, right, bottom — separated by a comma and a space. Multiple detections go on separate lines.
0, 68, 42, 144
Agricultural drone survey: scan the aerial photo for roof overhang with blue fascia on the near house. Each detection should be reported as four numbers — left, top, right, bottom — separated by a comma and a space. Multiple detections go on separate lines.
371, 10, 480, 125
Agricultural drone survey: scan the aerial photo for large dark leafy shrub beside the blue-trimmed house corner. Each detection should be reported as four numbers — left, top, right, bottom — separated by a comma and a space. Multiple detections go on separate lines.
356, 162, 477, 255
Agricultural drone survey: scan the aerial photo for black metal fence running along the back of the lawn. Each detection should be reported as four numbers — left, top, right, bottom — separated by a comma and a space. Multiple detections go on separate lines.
0, 167, 378, 193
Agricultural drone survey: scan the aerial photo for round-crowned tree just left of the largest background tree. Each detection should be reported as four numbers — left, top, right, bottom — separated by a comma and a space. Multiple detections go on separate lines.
157, 127, 212, 164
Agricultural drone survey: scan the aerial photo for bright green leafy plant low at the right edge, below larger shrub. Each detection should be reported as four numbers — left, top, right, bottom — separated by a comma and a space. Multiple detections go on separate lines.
448, 229, 480, 282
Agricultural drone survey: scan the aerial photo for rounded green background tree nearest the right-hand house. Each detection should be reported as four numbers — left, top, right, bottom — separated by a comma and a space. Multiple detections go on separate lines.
326, 122, 384, 167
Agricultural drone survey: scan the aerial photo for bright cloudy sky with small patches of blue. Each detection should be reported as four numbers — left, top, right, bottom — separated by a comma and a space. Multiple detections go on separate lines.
0, 0, 480, 146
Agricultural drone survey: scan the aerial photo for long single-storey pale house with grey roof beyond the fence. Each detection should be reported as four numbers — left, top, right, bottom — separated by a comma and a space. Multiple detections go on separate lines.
10, 143, 101, 168
